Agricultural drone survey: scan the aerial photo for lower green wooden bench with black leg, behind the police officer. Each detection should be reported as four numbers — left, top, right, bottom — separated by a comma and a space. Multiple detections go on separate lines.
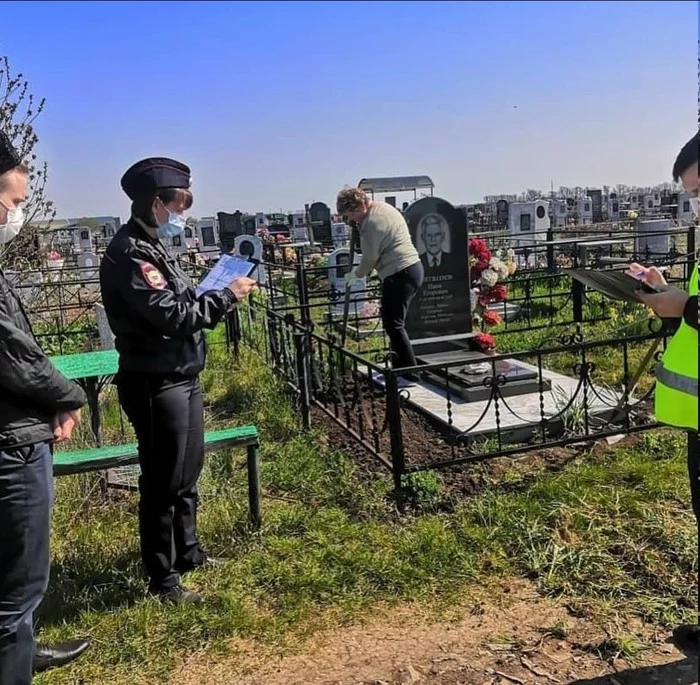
53, 426, 262, 530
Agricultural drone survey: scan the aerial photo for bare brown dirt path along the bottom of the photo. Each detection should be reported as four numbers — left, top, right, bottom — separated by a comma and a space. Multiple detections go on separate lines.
171, 584, 698, 685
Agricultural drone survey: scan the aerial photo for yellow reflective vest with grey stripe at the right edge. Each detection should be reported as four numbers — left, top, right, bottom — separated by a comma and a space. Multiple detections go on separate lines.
655, 264, 698, 431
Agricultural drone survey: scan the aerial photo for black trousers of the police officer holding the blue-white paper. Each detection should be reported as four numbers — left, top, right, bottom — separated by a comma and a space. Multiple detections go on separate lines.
116, 372, 205, 591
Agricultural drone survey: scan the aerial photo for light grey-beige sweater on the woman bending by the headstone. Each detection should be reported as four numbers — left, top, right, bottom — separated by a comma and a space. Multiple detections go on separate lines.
356, 202, 420, 281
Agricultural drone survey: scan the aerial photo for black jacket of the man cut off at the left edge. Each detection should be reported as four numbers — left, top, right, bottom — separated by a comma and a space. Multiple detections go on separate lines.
0, 270, 85, 449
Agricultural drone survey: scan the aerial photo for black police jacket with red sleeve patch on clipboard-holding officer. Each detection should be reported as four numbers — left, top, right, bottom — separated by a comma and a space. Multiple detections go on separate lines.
100, 219, 236, 376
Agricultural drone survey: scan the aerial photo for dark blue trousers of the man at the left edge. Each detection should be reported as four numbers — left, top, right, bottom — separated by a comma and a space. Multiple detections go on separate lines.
0, 443, 53, 685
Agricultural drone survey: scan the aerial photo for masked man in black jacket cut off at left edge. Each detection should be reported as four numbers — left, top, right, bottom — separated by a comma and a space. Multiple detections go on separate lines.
0, 132, 87, 685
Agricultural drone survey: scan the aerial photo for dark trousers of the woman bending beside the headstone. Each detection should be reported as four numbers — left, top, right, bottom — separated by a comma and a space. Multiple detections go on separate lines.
382, 262, 425, 369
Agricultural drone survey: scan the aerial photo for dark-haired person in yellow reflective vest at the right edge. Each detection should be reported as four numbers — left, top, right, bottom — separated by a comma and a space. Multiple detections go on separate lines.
630, 133, 700, 653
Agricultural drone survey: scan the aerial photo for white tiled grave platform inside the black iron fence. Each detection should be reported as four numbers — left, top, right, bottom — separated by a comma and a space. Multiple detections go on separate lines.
365, 362, 633, 435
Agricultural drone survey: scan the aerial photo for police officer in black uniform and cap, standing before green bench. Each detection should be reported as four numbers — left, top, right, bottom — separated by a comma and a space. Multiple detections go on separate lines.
100, 158, 255, 603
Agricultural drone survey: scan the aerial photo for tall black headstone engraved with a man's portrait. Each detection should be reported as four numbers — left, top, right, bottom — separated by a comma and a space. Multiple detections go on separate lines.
405, 197, 472, 340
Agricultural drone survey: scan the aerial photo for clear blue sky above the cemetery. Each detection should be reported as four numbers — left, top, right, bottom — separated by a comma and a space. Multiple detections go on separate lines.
0, 2, 698, 217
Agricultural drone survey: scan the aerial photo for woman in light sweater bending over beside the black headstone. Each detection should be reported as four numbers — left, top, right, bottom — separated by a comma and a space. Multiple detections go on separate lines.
336, 188, 424, 380
